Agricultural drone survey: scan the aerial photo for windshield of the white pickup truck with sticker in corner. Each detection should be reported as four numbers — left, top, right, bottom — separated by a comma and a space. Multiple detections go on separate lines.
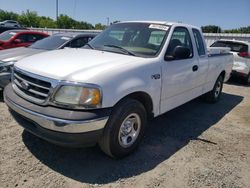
88, 23, 169, 57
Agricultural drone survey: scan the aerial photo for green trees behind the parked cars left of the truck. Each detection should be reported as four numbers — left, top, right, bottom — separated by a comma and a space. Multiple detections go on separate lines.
0, 9, 106, 30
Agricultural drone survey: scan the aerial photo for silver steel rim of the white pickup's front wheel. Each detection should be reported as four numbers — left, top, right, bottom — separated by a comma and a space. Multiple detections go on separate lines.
118, 113, 141, 148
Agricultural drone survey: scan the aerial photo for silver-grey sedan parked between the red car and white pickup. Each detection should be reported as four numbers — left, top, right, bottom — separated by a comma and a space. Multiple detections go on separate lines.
0, 33, 97, 88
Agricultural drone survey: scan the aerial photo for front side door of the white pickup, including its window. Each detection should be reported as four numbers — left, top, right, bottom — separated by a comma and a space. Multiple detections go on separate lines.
160, 27, 198, 113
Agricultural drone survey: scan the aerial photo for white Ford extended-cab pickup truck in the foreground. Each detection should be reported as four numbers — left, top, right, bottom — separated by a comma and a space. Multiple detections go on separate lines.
4, 21, 233, 158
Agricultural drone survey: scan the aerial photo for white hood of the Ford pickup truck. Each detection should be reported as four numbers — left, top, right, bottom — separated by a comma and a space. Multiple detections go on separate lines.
15, 48, 143, 81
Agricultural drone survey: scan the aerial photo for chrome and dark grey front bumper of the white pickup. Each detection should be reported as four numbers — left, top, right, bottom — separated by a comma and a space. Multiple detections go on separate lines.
4, 84, 111, 147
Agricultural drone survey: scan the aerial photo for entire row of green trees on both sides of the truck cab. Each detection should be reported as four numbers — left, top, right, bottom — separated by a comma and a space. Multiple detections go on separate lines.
0, 9, 250, 33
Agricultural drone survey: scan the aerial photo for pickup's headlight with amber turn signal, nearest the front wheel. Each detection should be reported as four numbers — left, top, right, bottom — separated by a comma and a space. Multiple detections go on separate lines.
54, 86, 102, 108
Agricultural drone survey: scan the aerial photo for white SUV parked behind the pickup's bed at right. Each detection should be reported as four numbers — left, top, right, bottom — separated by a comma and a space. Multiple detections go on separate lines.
211, 39, 250, 84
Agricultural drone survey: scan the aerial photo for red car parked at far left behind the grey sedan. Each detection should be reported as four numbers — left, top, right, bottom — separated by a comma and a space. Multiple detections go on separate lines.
0, 30, 49, 50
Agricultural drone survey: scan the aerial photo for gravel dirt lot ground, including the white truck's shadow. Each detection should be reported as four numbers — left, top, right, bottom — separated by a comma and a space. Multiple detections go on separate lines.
0, 83, 250, 188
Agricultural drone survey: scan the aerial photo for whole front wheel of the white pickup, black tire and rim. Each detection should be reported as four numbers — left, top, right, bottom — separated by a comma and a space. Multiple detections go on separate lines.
99, 99, 147, 158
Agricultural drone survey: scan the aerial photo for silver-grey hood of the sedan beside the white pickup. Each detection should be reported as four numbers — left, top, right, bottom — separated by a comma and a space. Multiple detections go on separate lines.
0, 47, 45, 62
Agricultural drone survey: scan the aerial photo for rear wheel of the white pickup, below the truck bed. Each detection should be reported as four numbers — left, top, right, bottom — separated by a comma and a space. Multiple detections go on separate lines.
205, 75, 223, 103
